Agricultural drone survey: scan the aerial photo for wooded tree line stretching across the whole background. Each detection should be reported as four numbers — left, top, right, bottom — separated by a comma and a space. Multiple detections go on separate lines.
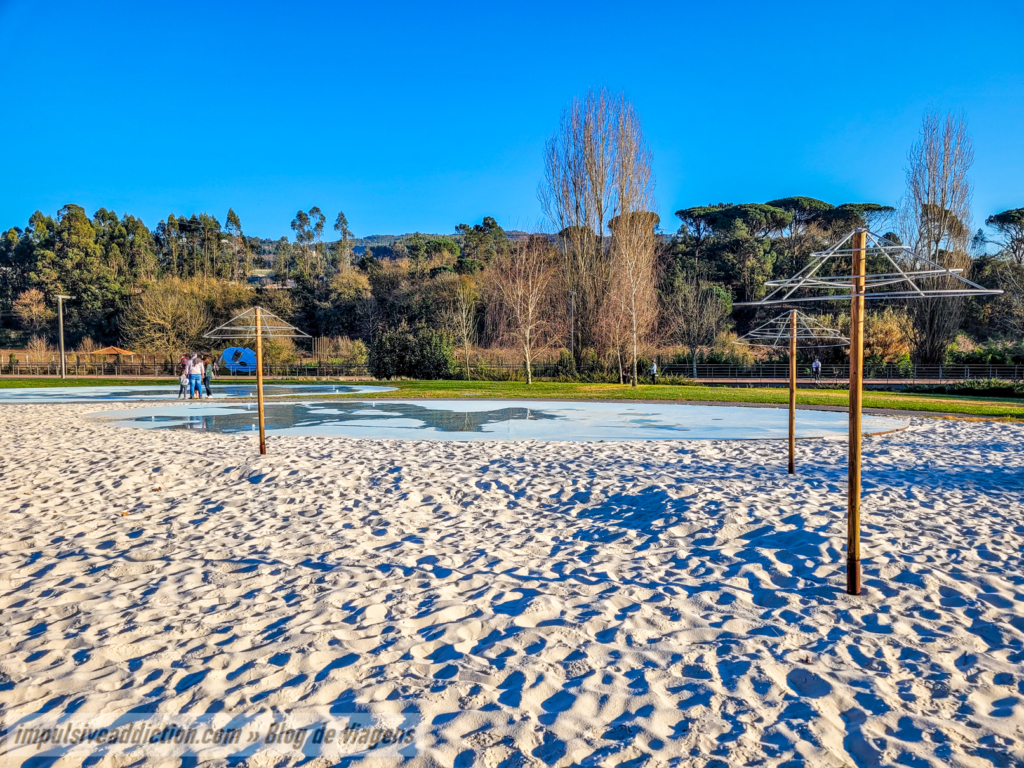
0, 89, 1024, 382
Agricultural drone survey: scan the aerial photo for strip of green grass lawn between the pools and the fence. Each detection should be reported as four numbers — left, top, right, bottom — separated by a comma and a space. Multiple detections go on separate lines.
0, 377, 1024, 421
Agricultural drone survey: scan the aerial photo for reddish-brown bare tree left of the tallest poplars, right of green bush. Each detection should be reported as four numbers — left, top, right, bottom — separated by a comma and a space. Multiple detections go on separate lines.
490, 237, 554, 384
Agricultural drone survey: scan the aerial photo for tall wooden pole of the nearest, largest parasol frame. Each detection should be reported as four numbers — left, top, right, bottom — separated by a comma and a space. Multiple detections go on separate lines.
846, 230, 867, 595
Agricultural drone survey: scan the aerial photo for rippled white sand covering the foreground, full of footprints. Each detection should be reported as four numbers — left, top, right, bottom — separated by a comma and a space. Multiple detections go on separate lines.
0, 403, 1024, 766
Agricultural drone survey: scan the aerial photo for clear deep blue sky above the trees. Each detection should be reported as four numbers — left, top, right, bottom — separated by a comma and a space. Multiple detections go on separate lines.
0, 0, 1024, 238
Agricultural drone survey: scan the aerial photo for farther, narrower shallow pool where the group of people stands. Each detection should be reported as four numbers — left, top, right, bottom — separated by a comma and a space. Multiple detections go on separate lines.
0, 380, 394, 403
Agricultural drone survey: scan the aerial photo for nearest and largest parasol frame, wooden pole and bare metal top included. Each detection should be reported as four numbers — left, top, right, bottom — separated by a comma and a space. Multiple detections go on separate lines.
733, 228, 1002, 595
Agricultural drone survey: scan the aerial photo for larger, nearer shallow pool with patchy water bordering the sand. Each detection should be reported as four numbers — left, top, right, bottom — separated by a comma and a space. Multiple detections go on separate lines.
89, 400, 906, 440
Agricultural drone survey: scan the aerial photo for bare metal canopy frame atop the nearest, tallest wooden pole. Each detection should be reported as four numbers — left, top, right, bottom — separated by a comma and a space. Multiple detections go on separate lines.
733, 229, 1002, 306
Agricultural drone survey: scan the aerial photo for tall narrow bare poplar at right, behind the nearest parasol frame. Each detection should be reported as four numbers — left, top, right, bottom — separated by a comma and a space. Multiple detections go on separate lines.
898, 114, 974, 364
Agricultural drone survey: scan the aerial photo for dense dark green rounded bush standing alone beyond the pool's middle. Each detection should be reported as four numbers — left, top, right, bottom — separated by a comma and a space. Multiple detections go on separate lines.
367, 328, 457, 379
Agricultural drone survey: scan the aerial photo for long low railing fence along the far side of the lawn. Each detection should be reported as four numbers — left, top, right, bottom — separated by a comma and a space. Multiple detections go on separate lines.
0, 359, 1024, 384
